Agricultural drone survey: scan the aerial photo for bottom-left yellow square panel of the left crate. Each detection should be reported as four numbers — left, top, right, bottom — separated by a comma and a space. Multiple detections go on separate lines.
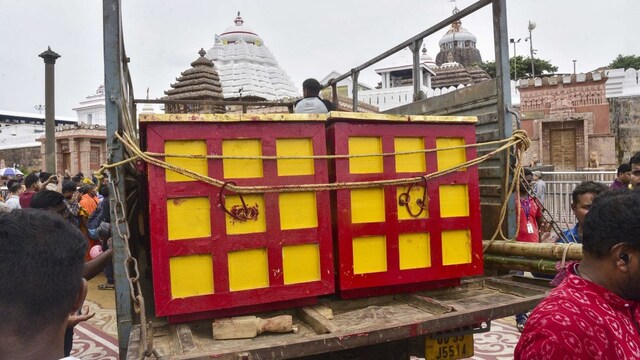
169, 254, 213, 299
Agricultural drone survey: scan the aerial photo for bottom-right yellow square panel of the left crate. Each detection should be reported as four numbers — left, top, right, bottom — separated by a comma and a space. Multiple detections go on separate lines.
282, 244, 320, 284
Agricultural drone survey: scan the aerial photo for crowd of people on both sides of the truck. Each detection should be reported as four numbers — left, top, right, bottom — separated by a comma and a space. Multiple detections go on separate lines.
0, 148, 640, 360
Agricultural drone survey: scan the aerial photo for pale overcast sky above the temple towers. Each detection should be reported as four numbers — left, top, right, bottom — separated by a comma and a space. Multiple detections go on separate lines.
0, 0, 640, 116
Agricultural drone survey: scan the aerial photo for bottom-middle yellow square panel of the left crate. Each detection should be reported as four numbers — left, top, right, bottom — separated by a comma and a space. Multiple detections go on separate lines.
228, 249, 269, 291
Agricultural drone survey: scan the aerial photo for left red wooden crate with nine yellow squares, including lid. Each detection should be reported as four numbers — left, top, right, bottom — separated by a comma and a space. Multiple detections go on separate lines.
140, 114, 334, 321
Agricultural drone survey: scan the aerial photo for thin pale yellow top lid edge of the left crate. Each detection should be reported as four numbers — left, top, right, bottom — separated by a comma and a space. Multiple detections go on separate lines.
139, 114, 328, 123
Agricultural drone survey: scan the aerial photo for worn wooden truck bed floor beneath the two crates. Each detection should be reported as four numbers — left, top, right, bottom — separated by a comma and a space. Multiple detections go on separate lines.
127, 275, 549, 359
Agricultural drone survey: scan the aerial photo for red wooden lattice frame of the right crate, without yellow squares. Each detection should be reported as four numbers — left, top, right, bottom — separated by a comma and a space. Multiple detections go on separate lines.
327, 122, 483, 298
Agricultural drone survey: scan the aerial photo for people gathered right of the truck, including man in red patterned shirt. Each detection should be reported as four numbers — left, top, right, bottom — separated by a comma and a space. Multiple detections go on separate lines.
515, 152, 640, 359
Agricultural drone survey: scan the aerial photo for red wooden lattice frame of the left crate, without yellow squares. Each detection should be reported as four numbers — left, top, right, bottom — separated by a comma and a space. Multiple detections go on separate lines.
144, 122, 334, 321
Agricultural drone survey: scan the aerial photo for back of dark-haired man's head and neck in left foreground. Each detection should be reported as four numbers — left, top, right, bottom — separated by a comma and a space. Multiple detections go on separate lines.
0, 209, 87, 360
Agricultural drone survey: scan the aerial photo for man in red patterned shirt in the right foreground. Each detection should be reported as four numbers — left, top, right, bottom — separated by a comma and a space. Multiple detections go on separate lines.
514, 190, 640, 360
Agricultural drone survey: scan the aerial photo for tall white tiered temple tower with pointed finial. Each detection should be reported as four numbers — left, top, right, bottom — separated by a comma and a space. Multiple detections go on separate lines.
206, 12, 300, 100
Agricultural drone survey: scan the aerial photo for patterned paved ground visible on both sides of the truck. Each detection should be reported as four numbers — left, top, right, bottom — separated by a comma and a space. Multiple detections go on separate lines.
80, 275, 520, 360
